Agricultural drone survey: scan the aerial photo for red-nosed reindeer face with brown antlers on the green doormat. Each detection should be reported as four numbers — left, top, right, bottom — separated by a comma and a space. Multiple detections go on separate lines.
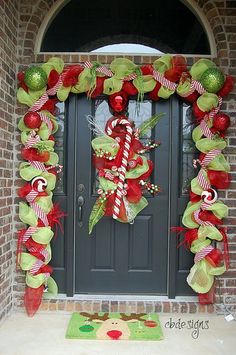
80, 312, 145, 340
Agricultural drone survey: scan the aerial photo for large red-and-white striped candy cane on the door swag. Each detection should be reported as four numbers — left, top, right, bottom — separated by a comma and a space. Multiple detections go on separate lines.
107, 118, 133, 219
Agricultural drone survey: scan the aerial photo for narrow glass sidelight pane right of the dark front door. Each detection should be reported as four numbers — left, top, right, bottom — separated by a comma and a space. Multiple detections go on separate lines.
180, 104, 197, 195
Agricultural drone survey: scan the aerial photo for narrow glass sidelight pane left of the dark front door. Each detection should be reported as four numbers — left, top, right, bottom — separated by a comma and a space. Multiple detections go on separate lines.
54, 102, 66, 194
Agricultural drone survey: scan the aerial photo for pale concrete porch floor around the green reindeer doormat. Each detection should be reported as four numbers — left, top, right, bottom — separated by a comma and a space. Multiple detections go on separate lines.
0, 312, 236, 355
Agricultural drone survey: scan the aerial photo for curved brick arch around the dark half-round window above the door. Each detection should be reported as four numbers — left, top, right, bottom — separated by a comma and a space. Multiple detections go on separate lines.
18, 0, 229, 66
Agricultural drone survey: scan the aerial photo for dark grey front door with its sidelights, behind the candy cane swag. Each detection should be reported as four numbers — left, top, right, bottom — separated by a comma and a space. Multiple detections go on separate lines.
50, 95, 195, 297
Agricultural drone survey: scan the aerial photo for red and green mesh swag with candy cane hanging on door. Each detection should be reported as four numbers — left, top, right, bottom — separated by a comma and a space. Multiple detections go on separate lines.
89, 115, 162, 234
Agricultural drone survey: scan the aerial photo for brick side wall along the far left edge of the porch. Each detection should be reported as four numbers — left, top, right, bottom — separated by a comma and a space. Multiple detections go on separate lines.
0, 0, 19, 320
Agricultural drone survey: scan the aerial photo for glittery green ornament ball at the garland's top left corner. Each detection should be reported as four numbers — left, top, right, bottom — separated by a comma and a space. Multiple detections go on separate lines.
24, 67, 47, 91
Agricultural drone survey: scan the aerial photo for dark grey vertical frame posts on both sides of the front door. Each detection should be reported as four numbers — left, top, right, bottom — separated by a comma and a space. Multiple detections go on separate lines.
65, 94, 183, 299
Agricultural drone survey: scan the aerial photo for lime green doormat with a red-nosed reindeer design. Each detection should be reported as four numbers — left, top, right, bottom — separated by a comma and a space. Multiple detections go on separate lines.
66, 312, 164, 340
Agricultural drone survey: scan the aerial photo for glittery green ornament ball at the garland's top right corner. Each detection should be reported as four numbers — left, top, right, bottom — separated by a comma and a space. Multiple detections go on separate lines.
200, 68, 225, 94
